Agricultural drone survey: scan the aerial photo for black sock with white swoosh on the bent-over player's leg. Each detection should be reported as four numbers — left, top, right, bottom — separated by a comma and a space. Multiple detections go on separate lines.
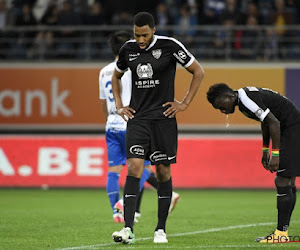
277, 186, 293, 231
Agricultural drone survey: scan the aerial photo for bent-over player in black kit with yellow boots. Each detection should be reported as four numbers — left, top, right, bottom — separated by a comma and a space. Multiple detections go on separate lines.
207, 83, 300, 243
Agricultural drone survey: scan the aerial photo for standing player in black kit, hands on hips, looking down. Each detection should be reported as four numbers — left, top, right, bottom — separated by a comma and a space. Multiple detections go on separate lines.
112, 12, 204, 244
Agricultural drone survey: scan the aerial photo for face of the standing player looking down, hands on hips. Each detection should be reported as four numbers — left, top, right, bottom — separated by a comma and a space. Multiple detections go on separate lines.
133, 25, 155, 49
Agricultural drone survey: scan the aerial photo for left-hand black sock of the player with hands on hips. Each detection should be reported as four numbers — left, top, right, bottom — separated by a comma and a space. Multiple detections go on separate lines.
124, 176, 140, 232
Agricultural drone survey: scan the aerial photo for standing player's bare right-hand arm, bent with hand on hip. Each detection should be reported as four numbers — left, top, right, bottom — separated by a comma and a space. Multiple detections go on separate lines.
163, 60, 204, 118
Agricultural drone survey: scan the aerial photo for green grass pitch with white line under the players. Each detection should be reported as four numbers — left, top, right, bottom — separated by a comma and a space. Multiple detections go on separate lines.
0, 189, 300, 250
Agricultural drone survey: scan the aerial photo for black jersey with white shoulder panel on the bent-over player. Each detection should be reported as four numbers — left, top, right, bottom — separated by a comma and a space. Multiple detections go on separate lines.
238, 87, 300, 130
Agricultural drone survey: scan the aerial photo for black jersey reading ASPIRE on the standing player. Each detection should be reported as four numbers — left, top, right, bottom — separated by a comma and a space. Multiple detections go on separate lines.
116, 35, 194, 120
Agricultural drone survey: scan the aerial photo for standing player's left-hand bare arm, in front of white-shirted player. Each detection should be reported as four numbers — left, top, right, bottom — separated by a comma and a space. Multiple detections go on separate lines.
111, 70, 135, 122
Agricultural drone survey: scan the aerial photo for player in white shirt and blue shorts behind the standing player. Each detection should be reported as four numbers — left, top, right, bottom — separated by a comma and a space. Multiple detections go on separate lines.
99, 31, 179, 223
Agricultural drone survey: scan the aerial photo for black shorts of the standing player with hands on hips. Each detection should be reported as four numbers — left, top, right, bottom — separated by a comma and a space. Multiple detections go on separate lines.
126, 118, 178, 165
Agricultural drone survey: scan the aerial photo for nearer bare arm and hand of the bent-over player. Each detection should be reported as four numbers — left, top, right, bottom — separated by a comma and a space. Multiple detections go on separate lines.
264, 112, 280, 171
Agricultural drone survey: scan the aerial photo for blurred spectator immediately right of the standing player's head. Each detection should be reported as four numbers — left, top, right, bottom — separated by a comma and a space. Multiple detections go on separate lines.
154, 3, 173, 36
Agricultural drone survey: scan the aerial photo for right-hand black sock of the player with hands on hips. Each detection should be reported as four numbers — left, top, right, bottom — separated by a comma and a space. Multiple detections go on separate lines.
155, 178, 172, 232
